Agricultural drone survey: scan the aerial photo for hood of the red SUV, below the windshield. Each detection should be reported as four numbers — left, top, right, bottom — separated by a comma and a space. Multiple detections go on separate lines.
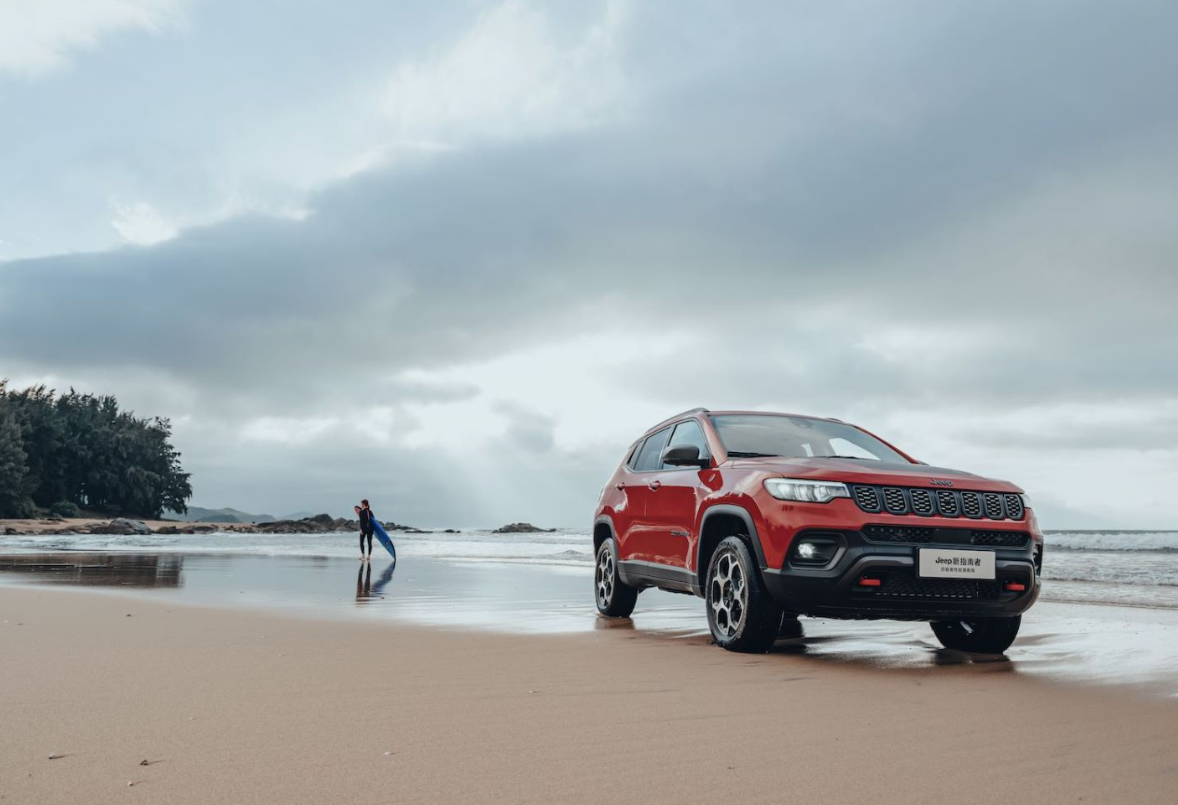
728, 456, 1023, 491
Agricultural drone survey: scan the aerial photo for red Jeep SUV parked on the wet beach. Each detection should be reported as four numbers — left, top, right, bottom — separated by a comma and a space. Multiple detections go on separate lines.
594, 408, 1043, 653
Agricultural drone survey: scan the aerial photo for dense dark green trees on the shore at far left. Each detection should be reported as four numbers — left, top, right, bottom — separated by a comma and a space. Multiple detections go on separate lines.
0, 380, 192, 517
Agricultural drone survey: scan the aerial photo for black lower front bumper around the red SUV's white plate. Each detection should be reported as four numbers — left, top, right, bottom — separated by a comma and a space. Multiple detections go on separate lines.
762, 529, 1041, 620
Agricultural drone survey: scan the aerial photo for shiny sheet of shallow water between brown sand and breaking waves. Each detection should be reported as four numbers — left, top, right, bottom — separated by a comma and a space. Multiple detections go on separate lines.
0, 548, 1178, 697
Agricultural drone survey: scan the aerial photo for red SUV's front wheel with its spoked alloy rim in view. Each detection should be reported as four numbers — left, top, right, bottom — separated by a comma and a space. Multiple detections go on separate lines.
704, 536, 783, 653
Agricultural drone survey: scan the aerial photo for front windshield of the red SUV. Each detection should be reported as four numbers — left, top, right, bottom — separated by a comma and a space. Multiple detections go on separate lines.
710, 414, 909, 463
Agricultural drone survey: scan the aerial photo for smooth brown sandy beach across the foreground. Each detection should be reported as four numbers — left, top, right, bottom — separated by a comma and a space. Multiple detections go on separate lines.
0, 588, 1178, 804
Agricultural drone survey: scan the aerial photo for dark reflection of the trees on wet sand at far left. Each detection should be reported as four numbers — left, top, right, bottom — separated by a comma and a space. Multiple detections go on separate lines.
0, 552, 184, 588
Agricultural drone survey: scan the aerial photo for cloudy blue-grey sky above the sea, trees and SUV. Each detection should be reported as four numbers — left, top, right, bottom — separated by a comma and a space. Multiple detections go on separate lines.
0, 0, 1178, 528
